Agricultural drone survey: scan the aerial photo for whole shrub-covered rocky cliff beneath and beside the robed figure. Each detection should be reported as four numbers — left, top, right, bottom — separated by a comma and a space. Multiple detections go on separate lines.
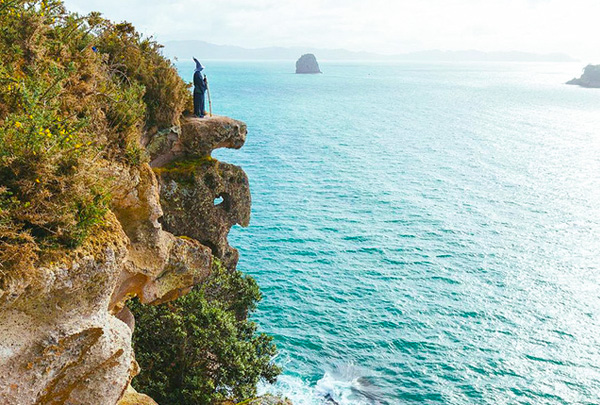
0, 0, 288, 405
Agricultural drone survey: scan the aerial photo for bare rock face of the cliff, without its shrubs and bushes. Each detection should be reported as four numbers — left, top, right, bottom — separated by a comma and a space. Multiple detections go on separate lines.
0, 117, 250, 405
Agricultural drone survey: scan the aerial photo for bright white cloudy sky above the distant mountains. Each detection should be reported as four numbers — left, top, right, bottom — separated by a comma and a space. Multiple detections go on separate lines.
65, 0, 600, 63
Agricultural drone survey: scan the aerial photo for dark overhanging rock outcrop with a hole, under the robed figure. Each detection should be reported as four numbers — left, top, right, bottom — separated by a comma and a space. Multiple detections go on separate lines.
149, 117, 251, 268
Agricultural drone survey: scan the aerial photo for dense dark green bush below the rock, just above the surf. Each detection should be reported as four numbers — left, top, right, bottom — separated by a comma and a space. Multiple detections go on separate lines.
130, 260, 280, 405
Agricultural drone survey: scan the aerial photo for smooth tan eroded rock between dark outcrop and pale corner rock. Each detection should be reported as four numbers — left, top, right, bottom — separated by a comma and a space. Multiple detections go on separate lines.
110, 161, 211, 313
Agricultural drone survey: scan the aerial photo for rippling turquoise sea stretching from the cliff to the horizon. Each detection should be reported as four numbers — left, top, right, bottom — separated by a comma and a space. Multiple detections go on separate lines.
175, 61, 600, 405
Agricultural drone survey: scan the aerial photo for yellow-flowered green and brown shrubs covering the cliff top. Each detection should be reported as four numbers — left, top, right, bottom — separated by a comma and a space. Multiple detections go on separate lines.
0, 0, 191, 290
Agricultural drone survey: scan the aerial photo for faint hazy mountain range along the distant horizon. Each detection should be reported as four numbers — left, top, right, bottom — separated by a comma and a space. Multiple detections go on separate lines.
164, 41, 576, 62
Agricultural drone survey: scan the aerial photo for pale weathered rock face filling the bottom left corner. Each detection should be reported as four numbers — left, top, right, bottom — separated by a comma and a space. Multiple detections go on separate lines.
0, 218, 137, 405
